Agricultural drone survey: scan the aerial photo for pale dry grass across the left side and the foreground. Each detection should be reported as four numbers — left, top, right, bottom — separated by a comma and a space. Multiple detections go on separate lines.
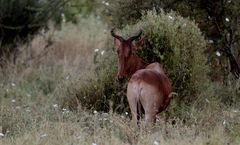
0, 18, 240, 145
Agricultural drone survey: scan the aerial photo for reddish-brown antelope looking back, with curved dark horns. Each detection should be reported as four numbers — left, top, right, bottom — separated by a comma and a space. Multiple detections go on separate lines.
111, 29, 174, 125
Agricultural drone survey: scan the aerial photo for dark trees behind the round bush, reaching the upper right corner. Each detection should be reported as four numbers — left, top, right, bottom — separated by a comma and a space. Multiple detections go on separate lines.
109, 0, 240, 81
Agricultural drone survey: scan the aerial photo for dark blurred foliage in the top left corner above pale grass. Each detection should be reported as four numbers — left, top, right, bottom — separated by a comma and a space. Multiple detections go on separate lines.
0, 0, 66, 63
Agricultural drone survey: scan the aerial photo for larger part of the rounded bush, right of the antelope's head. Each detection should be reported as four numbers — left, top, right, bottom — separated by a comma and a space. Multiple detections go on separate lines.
121, 11, 208, 102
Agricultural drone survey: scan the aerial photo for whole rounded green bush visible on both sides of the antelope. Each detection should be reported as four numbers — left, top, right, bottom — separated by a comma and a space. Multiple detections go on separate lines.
61, 11, 209, 111
